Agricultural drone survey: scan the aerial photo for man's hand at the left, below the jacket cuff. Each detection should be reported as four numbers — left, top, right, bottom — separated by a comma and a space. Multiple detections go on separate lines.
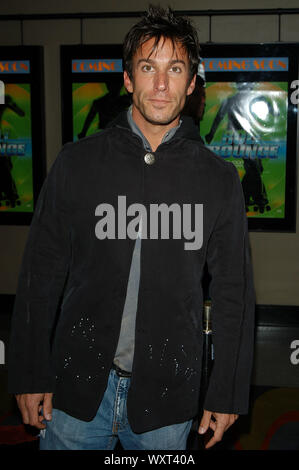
16, 393, 53, 429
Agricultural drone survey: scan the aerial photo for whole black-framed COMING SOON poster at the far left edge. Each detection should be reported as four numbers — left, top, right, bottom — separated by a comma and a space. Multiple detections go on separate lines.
0, 46, 45, 224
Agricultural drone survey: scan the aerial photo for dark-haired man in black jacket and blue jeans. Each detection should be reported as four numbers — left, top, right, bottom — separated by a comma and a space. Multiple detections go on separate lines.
9, 7, 254, 450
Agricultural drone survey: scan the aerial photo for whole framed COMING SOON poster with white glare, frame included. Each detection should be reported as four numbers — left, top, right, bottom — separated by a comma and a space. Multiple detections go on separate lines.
200, 44, 298, 231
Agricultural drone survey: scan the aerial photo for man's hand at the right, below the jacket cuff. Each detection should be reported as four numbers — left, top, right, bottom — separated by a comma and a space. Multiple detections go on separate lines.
198, 410, 239, 449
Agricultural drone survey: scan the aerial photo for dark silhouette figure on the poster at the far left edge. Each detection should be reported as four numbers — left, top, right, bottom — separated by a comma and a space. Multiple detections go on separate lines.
0, 95, 25, 207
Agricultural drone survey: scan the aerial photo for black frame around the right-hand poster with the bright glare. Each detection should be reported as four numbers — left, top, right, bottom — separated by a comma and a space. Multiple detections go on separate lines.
201, 43, 299, 233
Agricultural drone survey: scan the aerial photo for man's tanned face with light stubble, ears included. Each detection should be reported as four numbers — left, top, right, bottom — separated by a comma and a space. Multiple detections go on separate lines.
124, 38, 196, 125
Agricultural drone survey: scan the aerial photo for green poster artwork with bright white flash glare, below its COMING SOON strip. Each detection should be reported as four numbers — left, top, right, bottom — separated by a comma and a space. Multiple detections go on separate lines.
200, 82, 288, 218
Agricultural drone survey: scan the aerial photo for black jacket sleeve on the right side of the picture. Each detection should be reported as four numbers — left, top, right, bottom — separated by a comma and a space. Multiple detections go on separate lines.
204, 164, 255, 414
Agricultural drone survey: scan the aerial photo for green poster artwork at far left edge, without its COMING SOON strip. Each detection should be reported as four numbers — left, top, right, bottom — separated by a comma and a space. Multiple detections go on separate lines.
0, 83, 33, 212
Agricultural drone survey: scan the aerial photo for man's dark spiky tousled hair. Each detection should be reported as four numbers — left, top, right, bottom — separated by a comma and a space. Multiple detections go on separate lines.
123, 5, 200, 81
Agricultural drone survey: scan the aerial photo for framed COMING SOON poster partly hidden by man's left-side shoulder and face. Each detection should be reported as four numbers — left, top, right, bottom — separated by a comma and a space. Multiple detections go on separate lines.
61, 45, 131, 142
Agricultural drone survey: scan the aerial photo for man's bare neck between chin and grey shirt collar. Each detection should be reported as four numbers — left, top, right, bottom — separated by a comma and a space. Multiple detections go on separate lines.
132, 106, 180, 152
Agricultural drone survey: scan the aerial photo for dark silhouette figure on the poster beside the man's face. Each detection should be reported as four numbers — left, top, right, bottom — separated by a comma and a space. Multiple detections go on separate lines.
78, 76, 131, 139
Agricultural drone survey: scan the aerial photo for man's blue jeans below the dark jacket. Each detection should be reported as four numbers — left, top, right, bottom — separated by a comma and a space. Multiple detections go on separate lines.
40, 370, 192, 450
